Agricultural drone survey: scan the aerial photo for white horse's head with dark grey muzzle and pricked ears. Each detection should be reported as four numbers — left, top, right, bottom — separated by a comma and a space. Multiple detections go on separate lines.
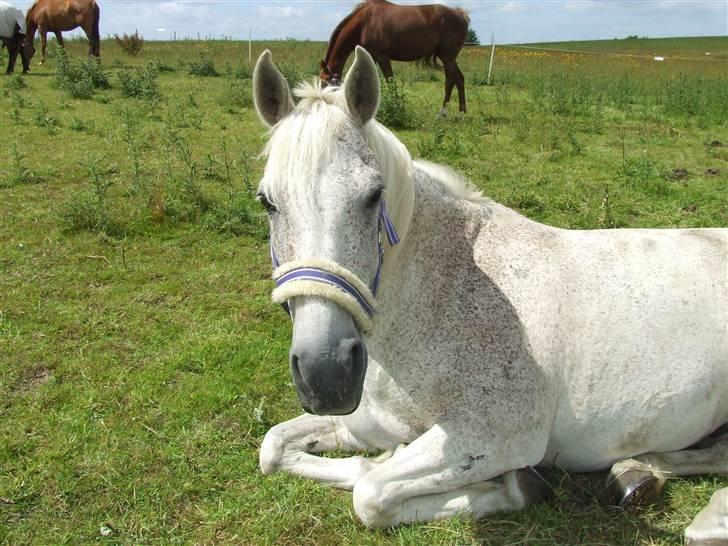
253, 48, 391, 415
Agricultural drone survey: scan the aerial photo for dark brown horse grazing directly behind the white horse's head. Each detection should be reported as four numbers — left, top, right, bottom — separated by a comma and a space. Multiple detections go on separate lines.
321, 0, 470, 114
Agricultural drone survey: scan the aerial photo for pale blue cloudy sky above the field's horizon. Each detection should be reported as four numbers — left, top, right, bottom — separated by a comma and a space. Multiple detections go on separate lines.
10, 0, 728, 44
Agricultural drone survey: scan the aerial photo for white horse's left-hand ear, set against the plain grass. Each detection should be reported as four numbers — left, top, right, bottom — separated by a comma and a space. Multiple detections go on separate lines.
253, 49, 294, 127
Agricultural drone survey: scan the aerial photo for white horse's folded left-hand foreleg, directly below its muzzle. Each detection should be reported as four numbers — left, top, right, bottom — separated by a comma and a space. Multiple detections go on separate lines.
260, 415, 389, 489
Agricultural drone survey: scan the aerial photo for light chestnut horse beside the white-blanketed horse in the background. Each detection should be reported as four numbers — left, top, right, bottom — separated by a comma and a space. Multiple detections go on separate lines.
25, 0, 101, 64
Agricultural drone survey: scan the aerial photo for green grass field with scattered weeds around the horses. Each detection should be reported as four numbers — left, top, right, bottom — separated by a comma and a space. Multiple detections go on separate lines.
0, 37, 728, 545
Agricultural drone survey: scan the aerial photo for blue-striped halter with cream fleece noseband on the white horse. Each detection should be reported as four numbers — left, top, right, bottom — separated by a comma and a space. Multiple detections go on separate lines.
270, 201, 399, 331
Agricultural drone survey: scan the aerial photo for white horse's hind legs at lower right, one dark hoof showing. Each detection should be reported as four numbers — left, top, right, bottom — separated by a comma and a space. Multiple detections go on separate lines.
607, 435, 728, 546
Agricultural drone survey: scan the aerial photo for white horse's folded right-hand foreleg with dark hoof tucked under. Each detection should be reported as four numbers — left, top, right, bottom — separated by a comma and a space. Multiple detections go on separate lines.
354, 427, 551, 527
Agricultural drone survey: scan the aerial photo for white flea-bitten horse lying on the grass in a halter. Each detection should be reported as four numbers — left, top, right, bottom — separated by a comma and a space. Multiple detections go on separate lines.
253, 48, 728, 540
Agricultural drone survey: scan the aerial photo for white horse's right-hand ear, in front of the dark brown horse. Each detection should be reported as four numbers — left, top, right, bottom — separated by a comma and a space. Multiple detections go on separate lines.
344, 46, 379, 123
